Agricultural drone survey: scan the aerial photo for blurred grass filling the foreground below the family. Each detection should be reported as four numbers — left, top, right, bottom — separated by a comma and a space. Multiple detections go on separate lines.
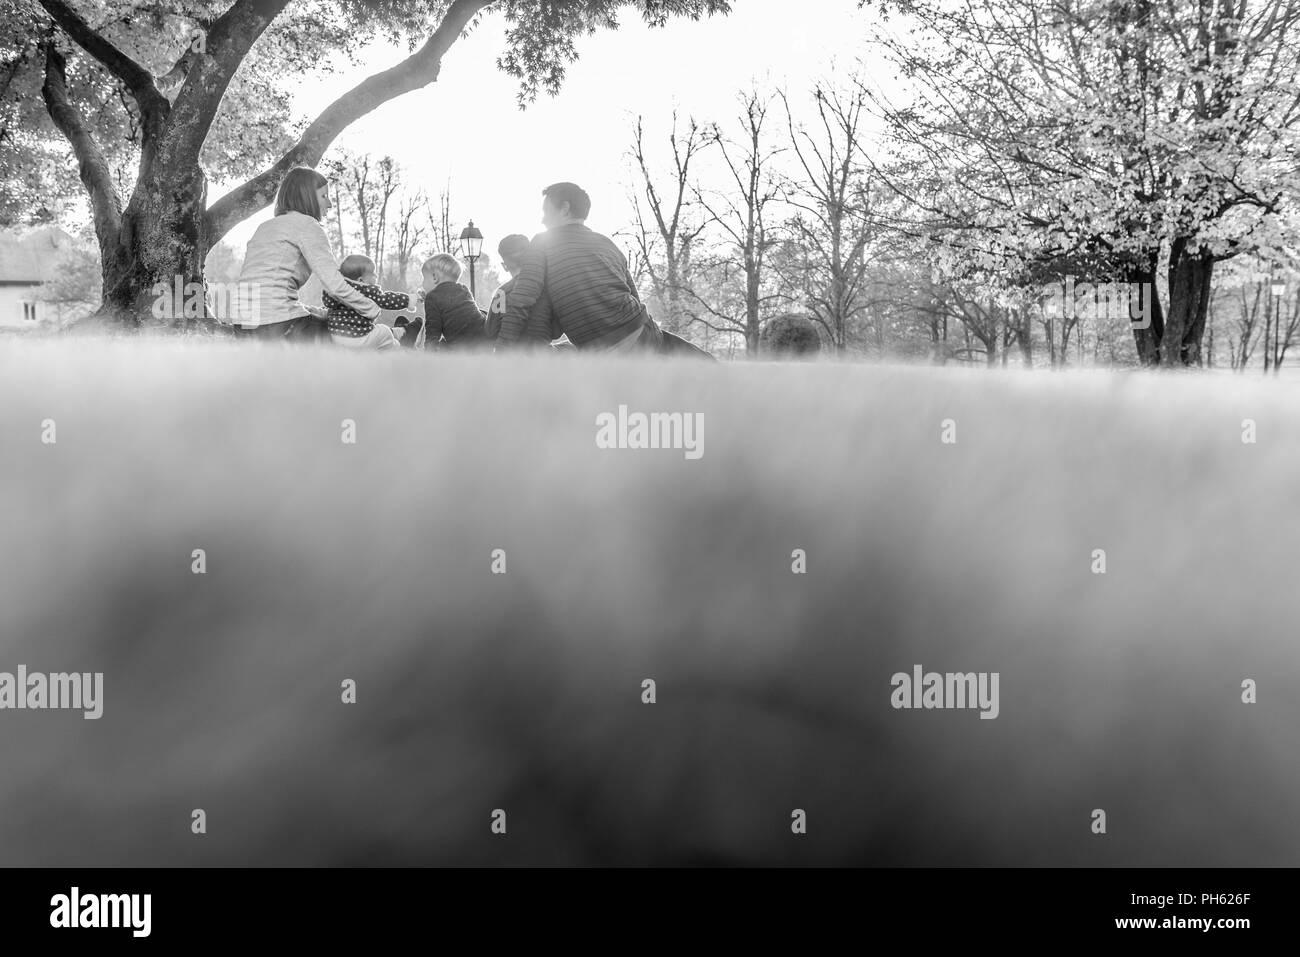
0, 342, 1300, 866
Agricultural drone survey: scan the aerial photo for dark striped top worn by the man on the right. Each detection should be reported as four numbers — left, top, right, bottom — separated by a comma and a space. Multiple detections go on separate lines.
497, 222, 649, 348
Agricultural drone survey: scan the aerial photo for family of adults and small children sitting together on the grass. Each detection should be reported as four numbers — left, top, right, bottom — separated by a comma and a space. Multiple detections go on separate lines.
233, 166, 709, 358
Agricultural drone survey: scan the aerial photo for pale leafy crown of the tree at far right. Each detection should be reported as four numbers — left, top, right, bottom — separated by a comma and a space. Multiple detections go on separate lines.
876, 0, 1300, 293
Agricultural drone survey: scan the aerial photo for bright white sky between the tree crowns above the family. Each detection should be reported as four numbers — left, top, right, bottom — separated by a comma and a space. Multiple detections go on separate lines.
212, 0, 884, 261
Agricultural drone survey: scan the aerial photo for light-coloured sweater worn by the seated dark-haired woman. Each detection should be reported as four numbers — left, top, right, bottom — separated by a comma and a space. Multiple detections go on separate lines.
231, 212, 380, 325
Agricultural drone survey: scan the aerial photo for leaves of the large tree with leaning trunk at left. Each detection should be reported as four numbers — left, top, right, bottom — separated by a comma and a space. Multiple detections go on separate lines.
12, 0, 728, 230
